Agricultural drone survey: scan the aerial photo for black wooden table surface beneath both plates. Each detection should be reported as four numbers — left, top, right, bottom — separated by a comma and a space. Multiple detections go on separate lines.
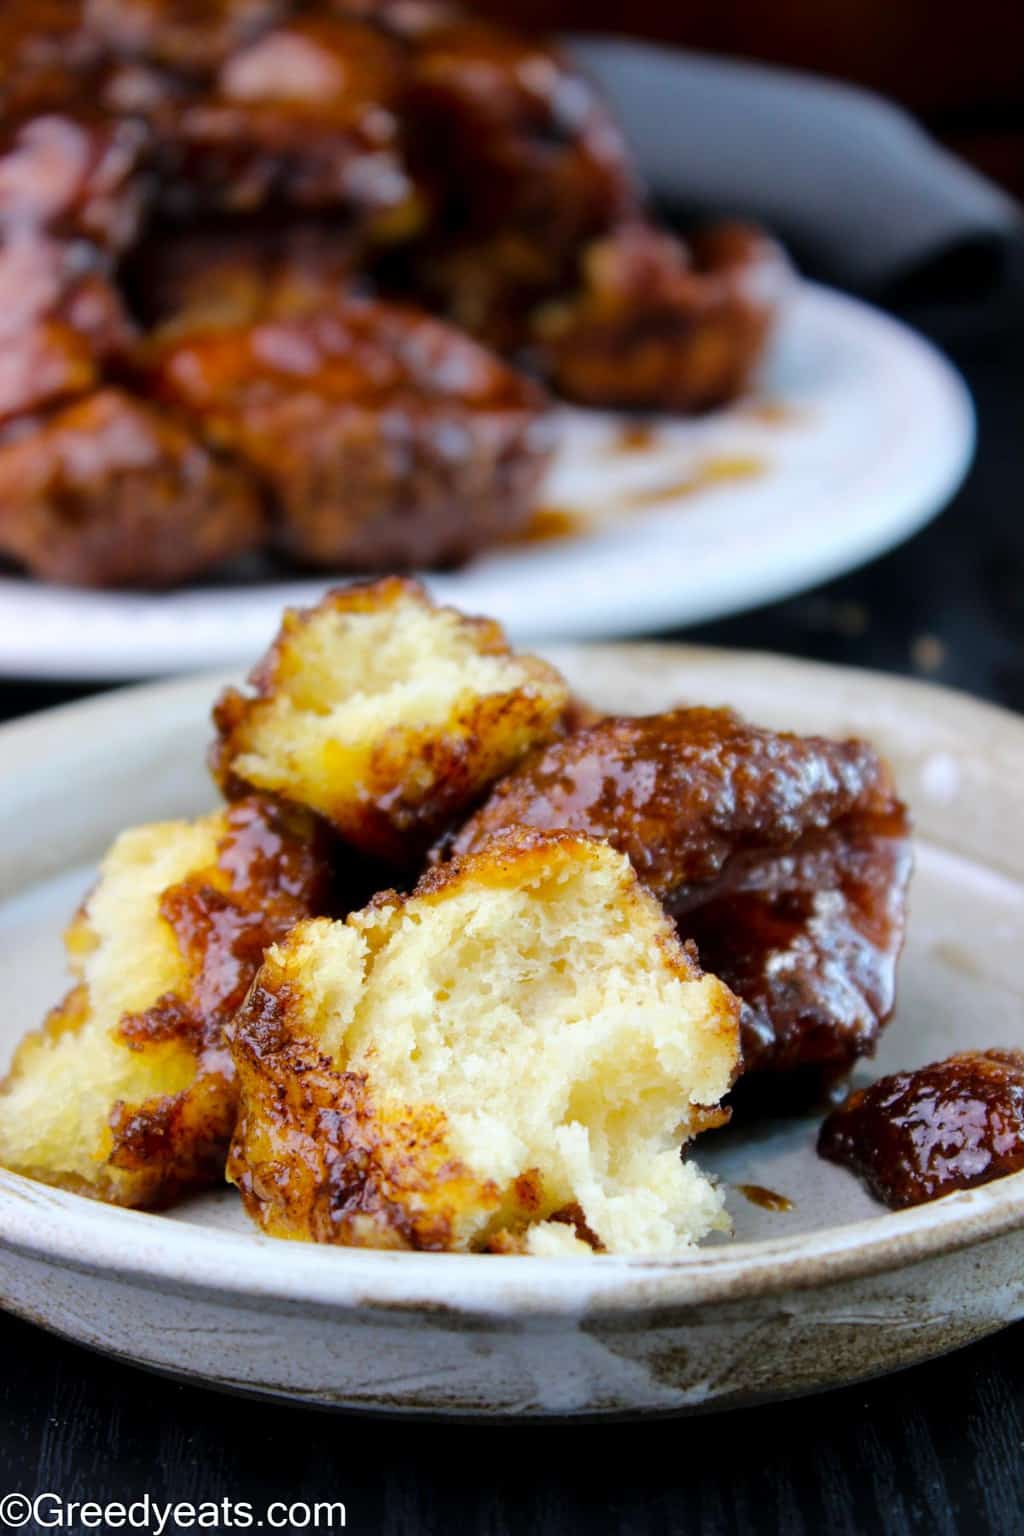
0, 255, 1024, 1536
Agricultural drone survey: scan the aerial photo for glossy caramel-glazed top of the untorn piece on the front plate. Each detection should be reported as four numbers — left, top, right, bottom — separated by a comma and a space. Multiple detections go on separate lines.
453, 708, 892, 900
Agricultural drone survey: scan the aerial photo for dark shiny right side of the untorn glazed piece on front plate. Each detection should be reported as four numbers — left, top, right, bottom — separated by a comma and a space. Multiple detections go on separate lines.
668, 806, 912, 1087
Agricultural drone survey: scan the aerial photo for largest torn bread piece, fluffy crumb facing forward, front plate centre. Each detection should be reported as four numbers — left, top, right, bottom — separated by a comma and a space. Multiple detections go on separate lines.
229, 834, 738, 1253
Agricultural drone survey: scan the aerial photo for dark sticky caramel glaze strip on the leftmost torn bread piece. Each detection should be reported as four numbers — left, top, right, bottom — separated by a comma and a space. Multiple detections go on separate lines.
103, 796, 330, 1204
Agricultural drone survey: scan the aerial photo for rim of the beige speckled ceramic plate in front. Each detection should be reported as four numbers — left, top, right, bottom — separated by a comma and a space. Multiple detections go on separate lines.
0, 644, 1024, 1319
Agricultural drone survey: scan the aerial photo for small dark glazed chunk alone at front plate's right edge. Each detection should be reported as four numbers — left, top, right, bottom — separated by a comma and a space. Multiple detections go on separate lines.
818, 1051, 1024, 1210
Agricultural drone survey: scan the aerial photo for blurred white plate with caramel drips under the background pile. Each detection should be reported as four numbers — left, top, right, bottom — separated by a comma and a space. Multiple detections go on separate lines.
0, 284, 973, 679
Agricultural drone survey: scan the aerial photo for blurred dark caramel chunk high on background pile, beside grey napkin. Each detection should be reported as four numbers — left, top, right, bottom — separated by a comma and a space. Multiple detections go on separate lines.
407, 20, 637, 350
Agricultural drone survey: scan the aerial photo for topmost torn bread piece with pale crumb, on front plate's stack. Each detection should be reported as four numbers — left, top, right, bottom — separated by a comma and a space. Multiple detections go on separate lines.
213, 578, 568, 865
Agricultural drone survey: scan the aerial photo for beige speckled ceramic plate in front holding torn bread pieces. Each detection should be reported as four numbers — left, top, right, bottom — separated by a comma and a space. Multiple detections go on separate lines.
0, 647, 1024, 1415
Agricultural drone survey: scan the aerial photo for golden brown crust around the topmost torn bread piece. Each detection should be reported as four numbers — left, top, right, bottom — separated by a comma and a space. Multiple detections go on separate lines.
210, 576, 568, 868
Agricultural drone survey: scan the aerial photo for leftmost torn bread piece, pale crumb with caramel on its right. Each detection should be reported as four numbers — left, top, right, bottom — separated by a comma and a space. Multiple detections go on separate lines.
0, 797, 329, 1206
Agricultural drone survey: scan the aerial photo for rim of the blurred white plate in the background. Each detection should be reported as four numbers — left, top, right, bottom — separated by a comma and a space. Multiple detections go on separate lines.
0, 278, 976, 680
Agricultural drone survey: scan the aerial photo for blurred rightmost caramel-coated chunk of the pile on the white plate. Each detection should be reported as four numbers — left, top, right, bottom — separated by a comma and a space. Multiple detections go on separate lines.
533, 223, 791, 412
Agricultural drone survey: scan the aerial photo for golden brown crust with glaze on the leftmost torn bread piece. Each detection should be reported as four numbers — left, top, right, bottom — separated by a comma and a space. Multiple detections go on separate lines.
3, 796, 330, 1207
